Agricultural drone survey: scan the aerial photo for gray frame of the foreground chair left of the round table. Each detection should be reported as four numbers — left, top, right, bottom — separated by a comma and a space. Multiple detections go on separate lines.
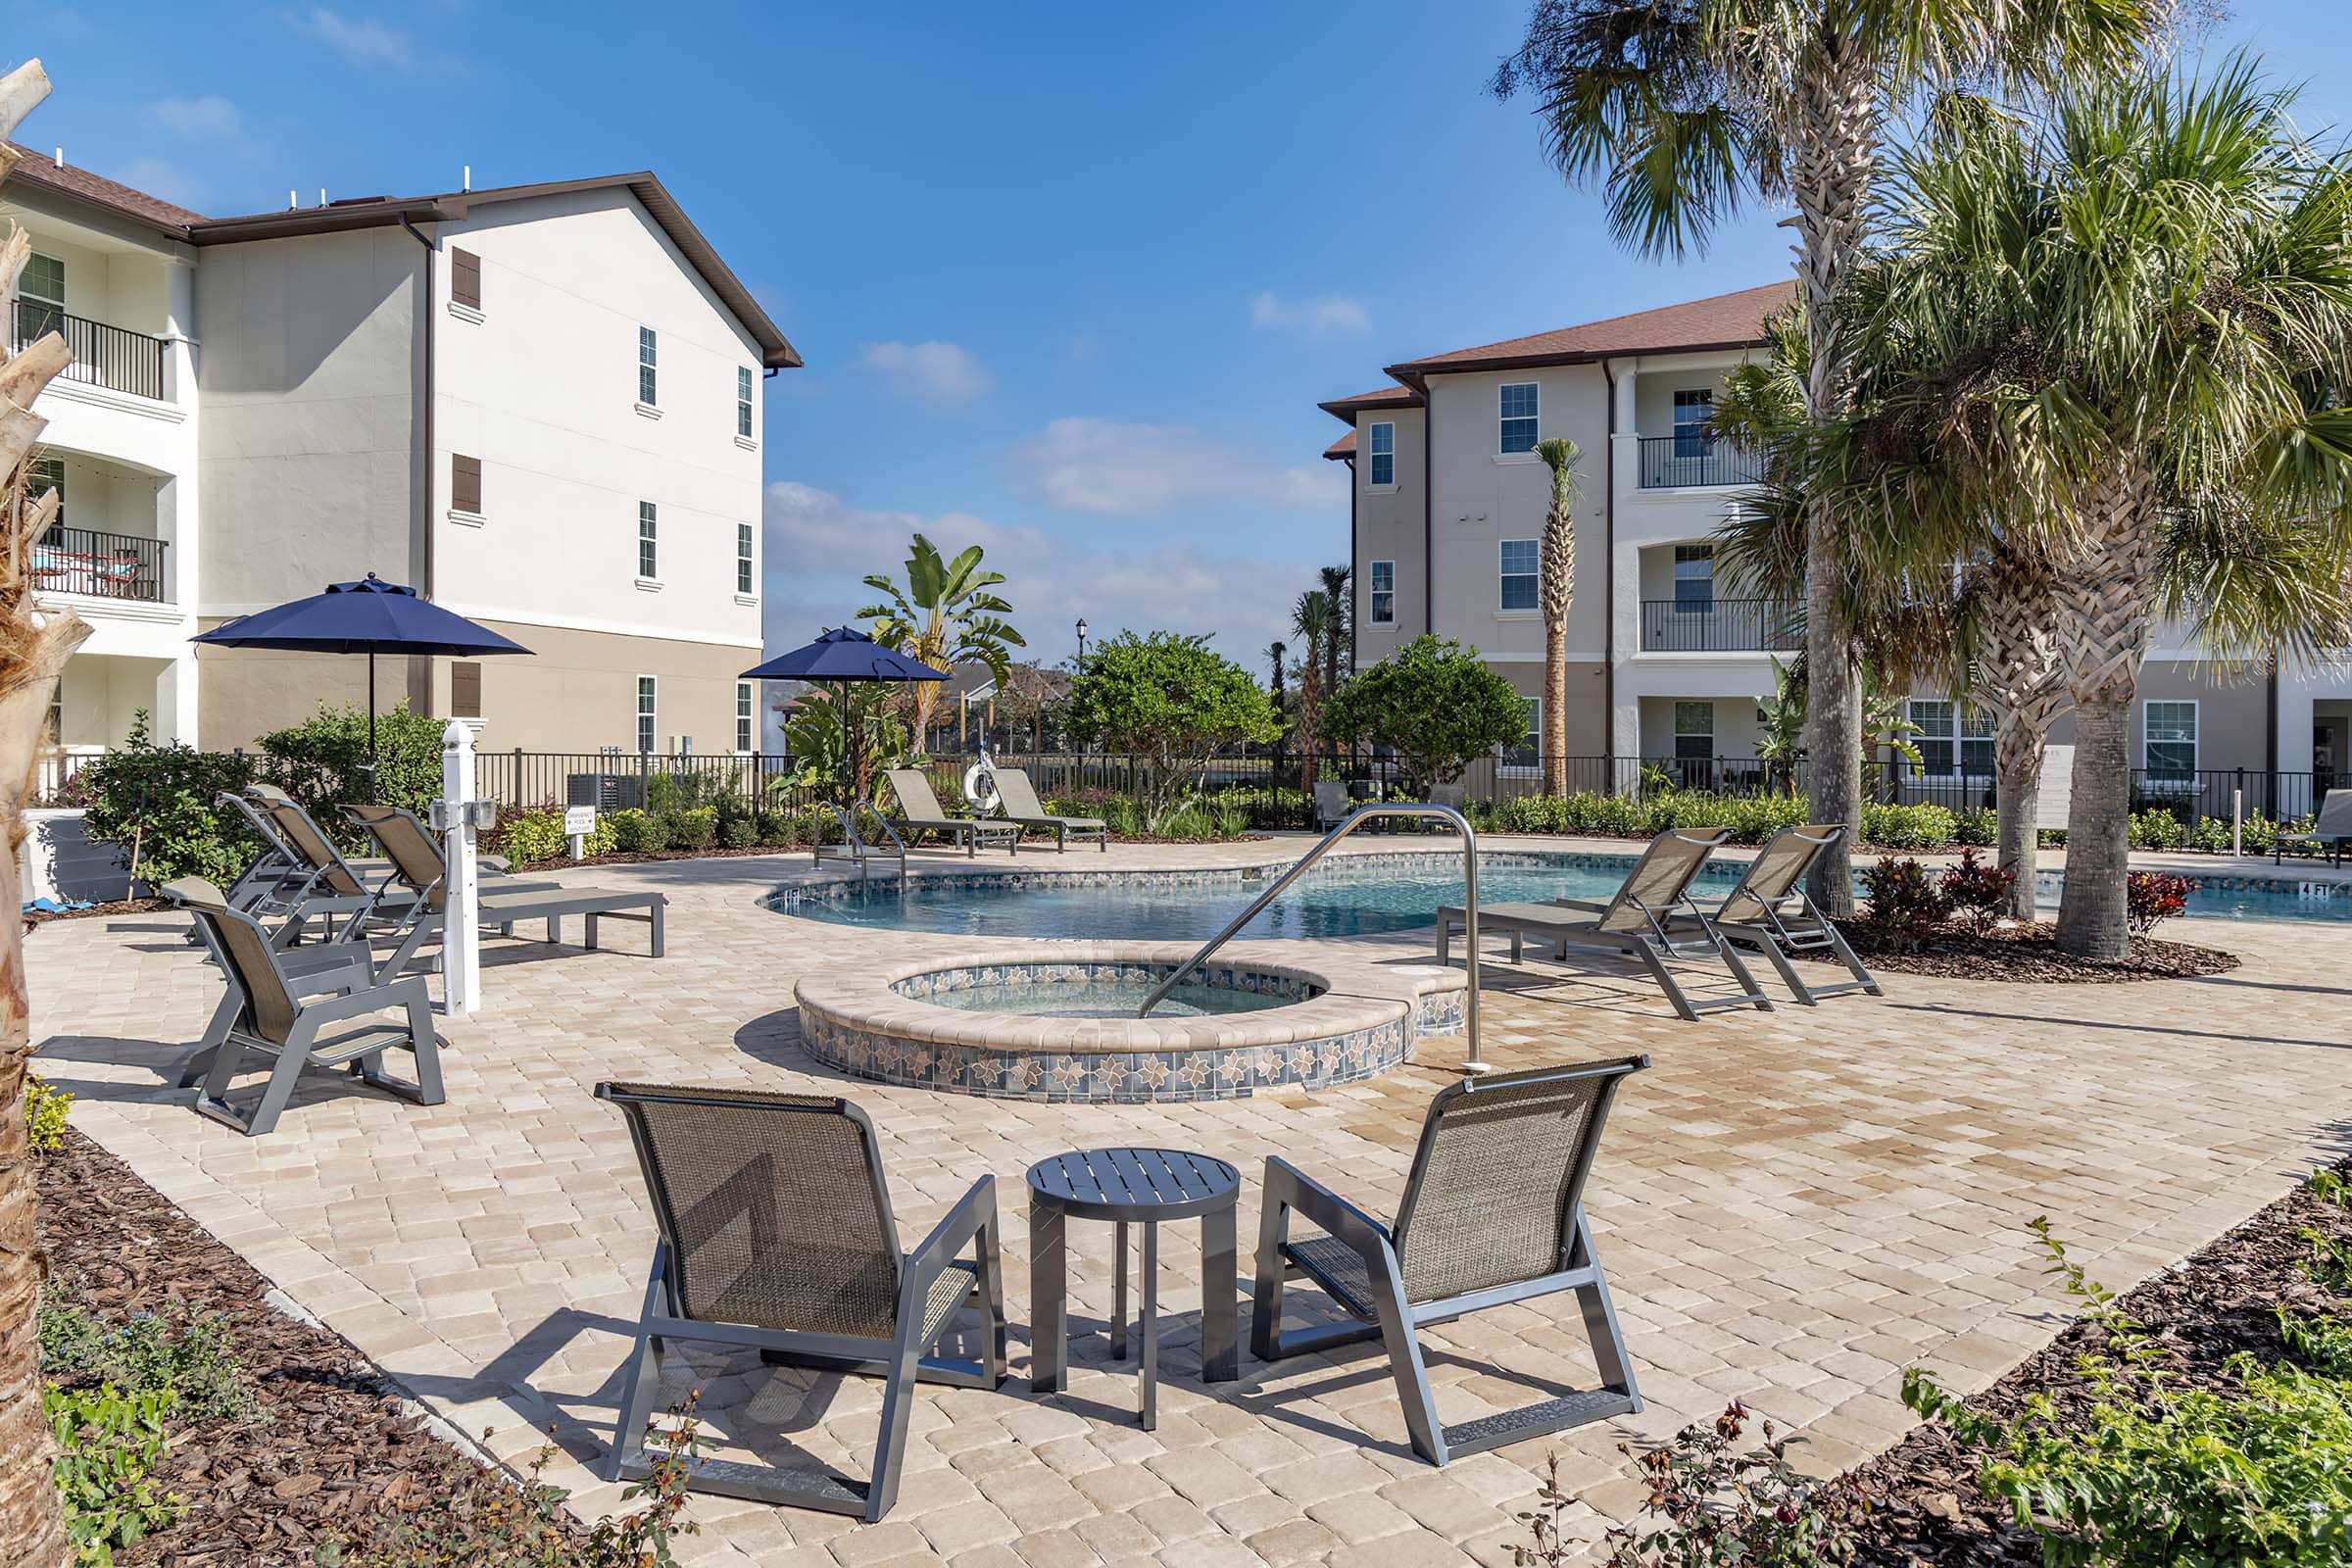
595, 1084, 1006, 1523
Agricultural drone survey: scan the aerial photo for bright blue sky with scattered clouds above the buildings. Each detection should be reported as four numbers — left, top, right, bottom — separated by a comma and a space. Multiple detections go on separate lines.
7, 0, 2352, 667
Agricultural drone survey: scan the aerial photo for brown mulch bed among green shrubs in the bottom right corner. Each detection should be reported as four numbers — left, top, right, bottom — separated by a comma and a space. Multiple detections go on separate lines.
1851, 1159, 2352, 1568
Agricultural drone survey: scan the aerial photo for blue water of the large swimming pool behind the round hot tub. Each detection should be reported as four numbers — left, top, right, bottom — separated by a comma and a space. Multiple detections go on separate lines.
766, 851, 2352, 943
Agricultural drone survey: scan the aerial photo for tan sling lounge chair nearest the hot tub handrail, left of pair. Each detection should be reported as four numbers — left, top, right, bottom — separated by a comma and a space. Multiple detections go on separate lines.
1437, 827, 1771, 1020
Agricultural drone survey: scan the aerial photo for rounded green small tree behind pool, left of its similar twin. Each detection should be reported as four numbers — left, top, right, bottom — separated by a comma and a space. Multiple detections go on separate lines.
1070, 632, 1280, 827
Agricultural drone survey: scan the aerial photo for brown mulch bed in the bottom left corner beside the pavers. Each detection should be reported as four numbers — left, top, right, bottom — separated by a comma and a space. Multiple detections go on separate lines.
37, 1128, 566, 1568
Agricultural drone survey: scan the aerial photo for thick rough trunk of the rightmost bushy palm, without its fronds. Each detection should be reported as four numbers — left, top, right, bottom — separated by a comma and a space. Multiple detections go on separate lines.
2058, 456, 2157, 959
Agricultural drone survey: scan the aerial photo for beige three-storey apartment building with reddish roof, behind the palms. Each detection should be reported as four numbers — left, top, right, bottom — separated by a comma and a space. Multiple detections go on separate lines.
1319, 282, 2352, 797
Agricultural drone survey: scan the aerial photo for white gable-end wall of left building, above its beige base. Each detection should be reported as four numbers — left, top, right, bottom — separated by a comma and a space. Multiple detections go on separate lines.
412, 190, 764, 662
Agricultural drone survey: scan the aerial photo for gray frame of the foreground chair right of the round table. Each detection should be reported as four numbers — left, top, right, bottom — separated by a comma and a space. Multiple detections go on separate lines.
1249, 1055, 1648, 1464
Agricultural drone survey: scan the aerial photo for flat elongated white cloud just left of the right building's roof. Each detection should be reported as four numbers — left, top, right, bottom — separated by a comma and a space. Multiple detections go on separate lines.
1011, 418, 1348, 517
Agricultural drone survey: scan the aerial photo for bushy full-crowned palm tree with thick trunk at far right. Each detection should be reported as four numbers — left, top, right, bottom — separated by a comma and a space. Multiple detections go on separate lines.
1863, 57, 2352, 956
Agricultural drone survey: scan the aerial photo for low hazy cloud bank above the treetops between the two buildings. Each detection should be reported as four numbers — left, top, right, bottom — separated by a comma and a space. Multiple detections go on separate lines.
762, 479, 1315, 670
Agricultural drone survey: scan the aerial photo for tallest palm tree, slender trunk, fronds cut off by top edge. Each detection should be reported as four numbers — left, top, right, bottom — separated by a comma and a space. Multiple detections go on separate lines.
1492, 0, 2169, 914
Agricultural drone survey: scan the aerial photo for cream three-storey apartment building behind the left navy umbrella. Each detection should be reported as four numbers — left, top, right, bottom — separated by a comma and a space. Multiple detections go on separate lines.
0, 151, 800, 753
